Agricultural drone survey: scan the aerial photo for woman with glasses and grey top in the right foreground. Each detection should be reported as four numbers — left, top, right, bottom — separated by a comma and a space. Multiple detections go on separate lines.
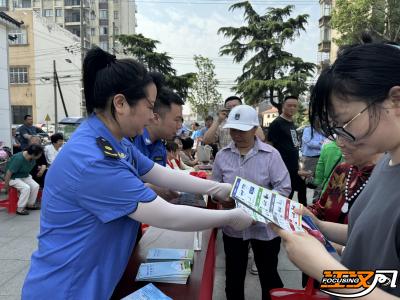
276, 44, 400, 299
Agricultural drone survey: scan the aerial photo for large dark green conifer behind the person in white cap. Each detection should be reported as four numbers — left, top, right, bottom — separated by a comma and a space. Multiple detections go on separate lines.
218, 1, 316, 111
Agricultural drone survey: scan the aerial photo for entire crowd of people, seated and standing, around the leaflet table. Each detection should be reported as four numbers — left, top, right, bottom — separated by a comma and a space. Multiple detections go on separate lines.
0, 38, 400, 300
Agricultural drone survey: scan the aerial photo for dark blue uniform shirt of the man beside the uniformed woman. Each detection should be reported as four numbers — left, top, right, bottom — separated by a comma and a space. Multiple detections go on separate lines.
133, 128, 167, 167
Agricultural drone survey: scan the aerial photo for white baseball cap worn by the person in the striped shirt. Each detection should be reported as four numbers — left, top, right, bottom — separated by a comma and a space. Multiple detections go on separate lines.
224, 105, 260, 131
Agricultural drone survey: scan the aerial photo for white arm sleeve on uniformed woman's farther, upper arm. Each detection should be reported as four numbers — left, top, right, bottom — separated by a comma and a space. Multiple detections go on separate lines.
142, 164, 232, 200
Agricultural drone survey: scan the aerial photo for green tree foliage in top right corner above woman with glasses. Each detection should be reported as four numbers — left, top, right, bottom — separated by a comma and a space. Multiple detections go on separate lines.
332, 0, 400, 46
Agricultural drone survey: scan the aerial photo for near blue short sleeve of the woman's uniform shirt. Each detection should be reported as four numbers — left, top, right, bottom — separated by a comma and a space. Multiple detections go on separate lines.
76, 158, 157, 223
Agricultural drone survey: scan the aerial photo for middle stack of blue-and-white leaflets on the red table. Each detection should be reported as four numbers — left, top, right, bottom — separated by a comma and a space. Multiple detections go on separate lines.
136, 261, 191, 284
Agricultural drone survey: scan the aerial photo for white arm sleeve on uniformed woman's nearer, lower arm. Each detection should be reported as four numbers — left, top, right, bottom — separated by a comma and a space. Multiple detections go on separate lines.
130, 197, 252, 231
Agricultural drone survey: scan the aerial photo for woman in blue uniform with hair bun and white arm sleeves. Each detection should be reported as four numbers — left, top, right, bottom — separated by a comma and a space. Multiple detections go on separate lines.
22, 48, 252, 300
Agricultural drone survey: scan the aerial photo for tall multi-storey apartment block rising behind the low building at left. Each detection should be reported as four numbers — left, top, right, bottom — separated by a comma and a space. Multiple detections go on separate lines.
0, 0, 137, 52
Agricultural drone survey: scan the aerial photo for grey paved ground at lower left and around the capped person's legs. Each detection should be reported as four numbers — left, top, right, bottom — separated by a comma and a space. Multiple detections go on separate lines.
0, 191, 310, 300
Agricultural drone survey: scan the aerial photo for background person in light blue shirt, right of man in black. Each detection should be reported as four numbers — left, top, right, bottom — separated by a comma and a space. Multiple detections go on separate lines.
301, 125, 326, 176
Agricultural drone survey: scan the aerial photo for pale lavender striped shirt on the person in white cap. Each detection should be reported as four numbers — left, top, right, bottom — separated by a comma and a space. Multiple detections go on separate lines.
212, 138, 291, 241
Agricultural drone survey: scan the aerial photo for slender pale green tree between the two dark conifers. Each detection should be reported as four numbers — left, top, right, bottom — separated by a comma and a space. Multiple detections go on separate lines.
188, 55, 222, 119
